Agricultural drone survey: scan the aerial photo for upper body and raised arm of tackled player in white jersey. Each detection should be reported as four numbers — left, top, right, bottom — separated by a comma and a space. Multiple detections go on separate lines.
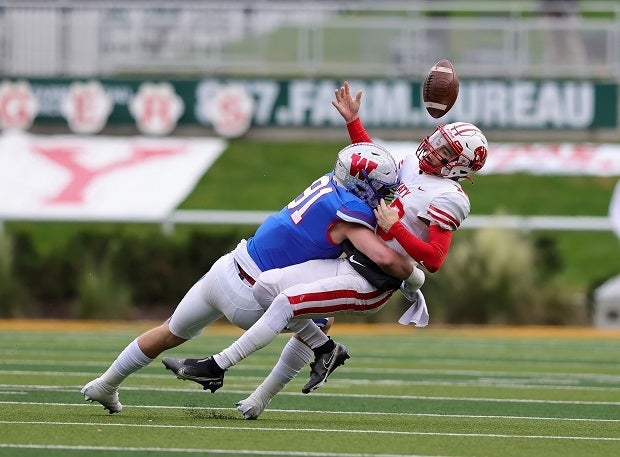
332, 82, 488, 272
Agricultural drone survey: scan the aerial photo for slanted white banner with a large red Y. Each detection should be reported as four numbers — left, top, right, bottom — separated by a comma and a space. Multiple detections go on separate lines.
0, 131, 226, 222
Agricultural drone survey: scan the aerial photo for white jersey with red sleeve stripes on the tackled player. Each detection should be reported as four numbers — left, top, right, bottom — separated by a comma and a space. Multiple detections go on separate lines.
379, 154, 471, 255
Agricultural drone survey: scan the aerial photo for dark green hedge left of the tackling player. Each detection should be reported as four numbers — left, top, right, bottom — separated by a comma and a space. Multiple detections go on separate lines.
0, 231, 239, 318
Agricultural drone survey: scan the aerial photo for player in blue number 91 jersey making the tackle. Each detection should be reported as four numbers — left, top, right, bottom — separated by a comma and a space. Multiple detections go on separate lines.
81, 143, 419, 413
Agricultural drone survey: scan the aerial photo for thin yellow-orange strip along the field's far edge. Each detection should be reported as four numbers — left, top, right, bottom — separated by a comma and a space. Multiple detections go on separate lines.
0, 319, 620, 339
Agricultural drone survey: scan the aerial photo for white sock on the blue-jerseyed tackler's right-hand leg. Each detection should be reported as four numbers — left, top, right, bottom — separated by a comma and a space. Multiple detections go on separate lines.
250, 337, 314, 405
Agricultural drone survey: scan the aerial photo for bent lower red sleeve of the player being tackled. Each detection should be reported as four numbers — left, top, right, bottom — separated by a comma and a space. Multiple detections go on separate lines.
388, 221, 452, 273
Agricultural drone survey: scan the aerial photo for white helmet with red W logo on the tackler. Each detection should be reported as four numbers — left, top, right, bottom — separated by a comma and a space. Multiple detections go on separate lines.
334, 143, 398, 208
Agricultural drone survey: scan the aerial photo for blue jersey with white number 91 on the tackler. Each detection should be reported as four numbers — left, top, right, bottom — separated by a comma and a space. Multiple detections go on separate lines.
247, 173, 376, 271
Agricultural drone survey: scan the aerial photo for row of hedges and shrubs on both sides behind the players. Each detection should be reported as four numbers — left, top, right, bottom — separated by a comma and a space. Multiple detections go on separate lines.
0, 225, 588, 325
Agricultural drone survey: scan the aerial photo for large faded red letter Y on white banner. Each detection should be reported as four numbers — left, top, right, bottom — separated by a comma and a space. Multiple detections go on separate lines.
33, 146, 184, 205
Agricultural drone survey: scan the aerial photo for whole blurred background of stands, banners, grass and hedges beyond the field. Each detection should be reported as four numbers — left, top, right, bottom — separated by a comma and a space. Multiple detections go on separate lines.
0, 0, 620, 328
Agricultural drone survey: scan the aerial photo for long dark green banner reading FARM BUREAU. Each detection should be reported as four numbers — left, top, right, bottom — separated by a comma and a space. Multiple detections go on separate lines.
0, 78, 619, 133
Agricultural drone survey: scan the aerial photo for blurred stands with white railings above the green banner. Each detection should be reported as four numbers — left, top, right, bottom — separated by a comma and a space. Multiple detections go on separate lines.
0, 0, 620, 80
